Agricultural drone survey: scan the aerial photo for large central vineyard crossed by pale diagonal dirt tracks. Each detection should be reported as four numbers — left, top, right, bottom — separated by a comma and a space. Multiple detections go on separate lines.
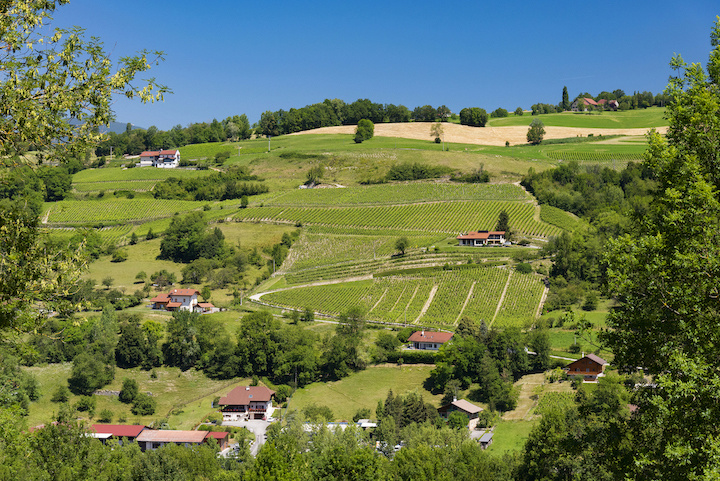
262, 266, 544, 327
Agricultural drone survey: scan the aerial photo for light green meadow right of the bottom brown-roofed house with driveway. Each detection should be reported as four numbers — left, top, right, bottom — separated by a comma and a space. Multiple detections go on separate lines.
288, 365, 442, 421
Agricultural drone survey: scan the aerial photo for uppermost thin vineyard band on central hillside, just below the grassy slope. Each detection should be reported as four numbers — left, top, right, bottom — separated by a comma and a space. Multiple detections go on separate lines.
264, 182, 530, 207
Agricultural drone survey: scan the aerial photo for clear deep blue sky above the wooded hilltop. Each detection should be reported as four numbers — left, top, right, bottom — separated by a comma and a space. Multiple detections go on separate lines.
53, 0, 720, 130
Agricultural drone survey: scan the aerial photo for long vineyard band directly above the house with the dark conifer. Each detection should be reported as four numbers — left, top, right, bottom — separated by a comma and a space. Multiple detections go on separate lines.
235, 201, 560, 237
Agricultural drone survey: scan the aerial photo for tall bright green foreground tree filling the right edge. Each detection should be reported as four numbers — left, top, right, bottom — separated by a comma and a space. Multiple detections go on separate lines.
603, 18, 720, 479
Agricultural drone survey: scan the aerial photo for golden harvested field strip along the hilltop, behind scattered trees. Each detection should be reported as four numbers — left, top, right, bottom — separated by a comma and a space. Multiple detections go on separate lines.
291, 122, 667, 146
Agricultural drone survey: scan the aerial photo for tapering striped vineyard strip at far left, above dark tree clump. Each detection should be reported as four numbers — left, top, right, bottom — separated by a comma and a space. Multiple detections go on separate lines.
44, 199, 205, 225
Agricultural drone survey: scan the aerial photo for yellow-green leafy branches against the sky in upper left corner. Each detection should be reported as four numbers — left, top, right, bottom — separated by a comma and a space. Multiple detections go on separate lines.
0, 0, 168, 160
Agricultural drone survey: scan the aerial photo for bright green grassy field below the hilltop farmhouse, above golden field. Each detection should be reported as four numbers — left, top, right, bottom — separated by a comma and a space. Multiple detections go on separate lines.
488, 107, 668, 129
